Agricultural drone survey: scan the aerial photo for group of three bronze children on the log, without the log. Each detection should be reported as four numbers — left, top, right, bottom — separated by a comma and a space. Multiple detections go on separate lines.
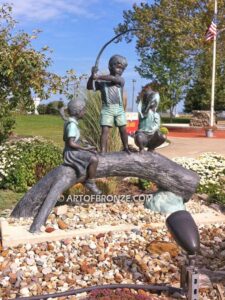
63, 55, 165, 194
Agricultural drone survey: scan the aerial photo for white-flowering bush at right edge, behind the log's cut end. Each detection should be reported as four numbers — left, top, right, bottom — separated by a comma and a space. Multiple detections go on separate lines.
175, 153, 225, 204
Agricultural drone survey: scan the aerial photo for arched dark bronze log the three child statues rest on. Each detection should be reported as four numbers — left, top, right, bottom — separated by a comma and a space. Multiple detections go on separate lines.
11, 152, 199, 232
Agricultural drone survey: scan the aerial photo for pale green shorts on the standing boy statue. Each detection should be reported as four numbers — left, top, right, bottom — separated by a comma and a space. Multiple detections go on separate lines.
100, 104, 127, 127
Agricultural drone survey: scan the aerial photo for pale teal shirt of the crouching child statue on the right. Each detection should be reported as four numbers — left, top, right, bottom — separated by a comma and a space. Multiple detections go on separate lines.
138, 110, 160, 134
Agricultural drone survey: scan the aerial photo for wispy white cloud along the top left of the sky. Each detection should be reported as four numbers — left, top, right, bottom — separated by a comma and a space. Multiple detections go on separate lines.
0, 0, 98, 21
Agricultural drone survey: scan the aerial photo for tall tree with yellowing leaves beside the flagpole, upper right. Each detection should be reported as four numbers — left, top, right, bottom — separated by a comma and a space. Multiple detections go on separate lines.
116, 0, 225, 113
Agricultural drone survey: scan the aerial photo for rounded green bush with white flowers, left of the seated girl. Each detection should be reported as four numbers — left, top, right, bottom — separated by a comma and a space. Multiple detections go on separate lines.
0, 138, 62, 192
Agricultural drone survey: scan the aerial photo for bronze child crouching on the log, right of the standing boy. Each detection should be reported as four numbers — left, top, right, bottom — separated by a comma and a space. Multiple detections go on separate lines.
134, 88, 166, 153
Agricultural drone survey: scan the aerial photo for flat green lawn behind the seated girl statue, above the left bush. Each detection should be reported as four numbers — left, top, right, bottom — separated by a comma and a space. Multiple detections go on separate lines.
13, 115, 63, 147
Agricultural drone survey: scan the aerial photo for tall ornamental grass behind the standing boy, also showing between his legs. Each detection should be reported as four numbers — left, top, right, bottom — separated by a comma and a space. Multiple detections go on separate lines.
80, 91, 122, 151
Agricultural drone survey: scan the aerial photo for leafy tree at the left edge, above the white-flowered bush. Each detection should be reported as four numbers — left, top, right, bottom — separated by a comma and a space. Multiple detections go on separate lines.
0, 4, 76, 143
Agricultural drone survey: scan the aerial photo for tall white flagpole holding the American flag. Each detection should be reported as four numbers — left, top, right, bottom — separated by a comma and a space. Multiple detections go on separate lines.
210, 0, 217, 126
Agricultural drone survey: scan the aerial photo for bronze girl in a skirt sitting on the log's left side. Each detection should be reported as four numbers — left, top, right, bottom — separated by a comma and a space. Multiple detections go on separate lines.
63, 99, 101, 195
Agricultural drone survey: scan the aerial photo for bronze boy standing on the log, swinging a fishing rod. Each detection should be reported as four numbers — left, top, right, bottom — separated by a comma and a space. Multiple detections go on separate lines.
87, 55, 130, 153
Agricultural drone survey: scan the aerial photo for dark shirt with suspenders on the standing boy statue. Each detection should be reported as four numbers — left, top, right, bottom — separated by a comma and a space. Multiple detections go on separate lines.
95, 81, 123, 105
